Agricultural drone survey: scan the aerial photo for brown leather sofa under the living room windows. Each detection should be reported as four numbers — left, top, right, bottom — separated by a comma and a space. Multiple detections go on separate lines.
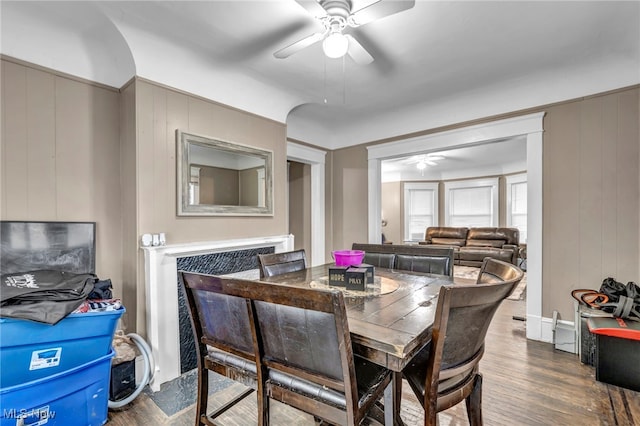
419, 226, 520, 267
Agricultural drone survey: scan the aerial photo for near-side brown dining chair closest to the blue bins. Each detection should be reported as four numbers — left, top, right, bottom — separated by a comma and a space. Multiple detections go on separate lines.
180, 272, 261, 425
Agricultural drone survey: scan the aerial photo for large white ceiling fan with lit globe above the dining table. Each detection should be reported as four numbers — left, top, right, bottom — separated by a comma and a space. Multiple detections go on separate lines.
273, 0, 415, 65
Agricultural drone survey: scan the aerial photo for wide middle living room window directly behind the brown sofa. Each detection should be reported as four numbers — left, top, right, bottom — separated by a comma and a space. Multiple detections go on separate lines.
445, 178, 498, 227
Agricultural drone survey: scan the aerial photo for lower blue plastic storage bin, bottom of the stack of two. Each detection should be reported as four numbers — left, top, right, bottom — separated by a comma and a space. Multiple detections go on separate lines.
0, 350, 115, 426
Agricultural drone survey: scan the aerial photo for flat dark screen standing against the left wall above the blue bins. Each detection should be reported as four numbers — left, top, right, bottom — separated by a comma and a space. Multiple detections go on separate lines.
0, 220, 96, 274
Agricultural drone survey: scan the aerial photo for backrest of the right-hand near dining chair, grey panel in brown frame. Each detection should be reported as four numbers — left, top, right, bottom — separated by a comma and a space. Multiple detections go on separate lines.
253, 283, 358, 419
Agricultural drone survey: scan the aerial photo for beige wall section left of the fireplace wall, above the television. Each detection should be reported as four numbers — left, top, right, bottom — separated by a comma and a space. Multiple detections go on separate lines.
0, 59, 123, 302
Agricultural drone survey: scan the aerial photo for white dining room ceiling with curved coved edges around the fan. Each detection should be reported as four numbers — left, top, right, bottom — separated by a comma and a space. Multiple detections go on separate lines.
0, 0, 640, 149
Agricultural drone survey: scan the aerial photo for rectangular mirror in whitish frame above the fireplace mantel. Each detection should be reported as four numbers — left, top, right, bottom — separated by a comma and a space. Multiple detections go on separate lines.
176, 130, 273, 216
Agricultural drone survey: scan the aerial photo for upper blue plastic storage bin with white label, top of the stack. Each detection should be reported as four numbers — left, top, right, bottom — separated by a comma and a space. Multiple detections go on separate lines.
0, 308, 125, 388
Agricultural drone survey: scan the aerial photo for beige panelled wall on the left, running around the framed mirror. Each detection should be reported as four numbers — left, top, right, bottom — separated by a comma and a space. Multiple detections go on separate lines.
0, 62, 288, 335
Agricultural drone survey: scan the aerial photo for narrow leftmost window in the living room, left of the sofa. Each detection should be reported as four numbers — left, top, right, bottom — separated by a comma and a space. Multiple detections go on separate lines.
403, 182, 438, 241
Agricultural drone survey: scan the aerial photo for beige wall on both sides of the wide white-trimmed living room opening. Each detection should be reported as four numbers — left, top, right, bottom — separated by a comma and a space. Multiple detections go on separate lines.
332, 87, 640, 321
